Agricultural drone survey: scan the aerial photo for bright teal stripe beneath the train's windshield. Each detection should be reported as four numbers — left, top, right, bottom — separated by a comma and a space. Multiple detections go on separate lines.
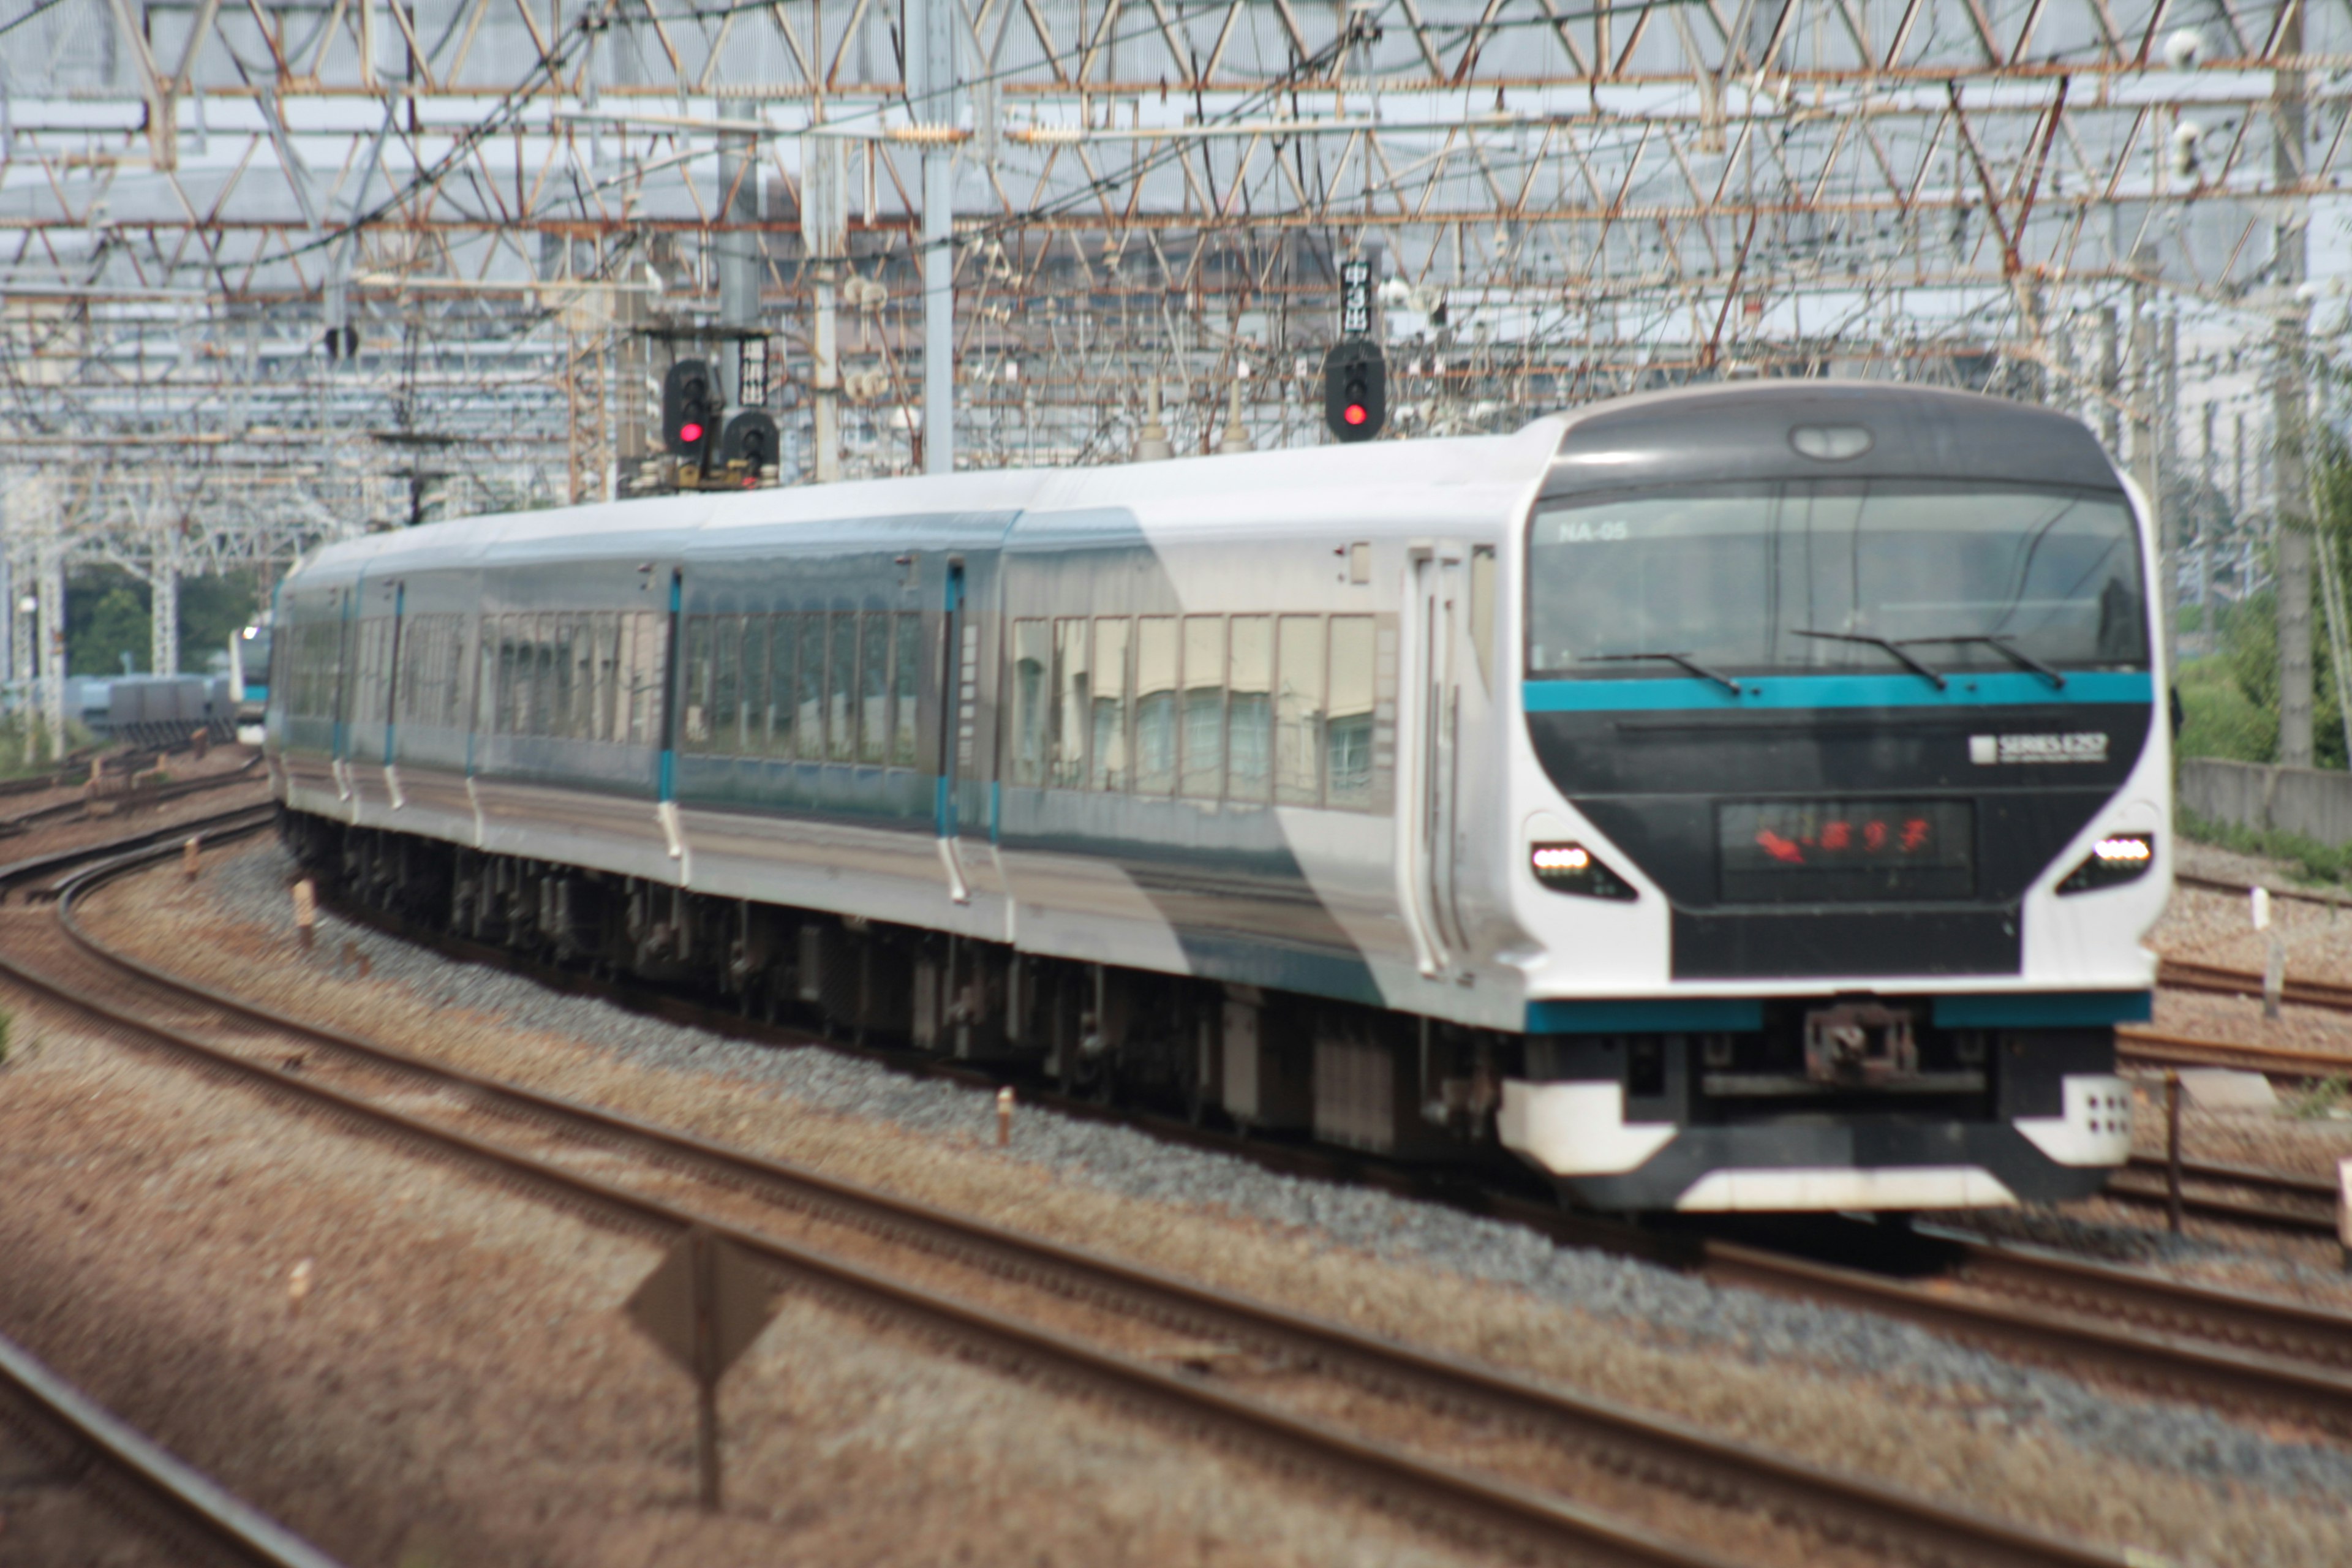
1521, 670, 2157, 712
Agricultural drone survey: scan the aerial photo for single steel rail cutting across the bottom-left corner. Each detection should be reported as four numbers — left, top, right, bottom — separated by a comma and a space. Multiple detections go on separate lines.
0, 1338, 336, 1568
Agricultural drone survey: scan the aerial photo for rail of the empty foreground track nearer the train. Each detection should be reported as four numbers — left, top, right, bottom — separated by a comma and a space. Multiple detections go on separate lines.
50, 823, 2154, 1568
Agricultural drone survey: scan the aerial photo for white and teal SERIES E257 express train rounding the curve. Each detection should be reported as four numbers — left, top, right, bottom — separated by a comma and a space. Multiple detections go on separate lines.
268, 381, 2171, 1211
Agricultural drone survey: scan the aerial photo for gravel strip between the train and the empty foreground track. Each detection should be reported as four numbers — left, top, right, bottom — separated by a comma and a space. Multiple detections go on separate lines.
37, 844, 2314, 1563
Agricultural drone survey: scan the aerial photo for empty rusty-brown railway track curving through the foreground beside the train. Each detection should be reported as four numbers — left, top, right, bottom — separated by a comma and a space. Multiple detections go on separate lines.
0, 820, 2154, 1566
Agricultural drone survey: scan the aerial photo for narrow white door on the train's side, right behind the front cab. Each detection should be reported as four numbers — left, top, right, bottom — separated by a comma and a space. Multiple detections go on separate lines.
1397, 545, 1465, 976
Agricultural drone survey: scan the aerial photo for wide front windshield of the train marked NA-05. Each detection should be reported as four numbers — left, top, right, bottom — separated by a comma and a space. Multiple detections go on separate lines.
1526, 480, 2147, 679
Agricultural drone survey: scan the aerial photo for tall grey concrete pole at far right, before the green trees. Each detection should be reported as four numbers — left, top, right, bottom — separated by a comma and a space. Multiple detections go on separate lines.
2270, 9, 2312, 769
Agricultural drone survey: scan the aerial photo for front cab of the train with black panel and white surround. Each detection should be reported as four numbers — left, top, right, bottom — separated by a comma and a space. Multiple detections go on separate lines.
1498, 383, 2171, 1211
